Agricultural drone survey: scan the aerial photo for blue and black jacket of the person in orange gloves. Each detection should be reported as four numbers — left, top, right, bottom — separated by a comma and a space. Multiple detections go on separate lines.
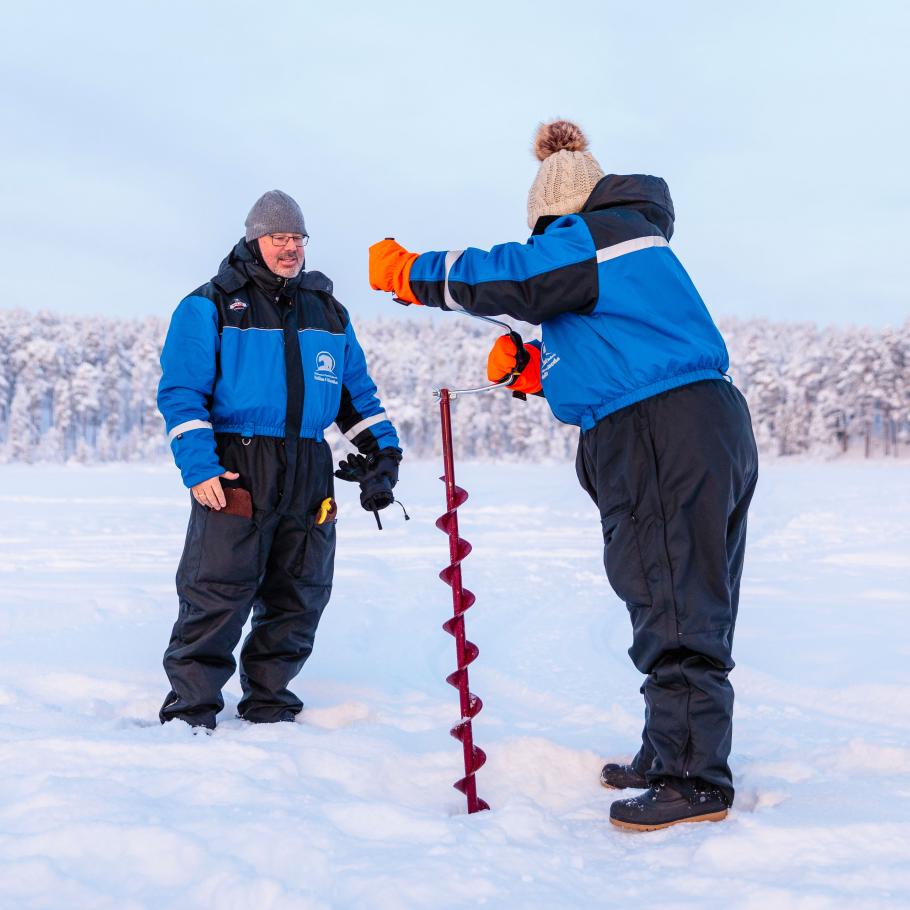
410, 174, 729, 430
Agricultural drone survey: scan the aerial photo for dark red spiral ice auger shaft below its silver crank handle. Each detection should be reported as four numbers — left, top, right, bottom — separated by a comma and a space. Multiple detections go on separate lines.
436, 389, 490, 813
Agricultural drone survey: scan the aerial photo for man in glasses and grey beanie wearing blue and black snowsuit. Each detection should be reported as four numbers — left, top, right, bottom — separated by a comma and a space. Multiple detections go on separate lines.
158, 190, 401, 728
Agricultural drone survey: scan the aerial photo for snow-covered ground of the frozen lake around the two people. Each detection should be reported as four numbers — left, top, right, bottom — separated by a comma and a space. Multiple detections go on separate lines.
0, 462, 910, 910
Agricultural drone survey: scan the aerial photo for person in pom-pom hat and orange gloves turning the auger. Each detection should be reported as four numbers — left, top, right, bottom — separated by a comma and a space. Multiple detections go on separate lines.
370, 121, 758, 830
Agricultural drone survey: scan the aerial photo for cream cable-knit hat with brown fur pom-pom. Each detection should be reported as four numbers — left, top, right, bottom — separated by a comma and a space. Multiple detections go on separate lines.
528, 120, 604, 230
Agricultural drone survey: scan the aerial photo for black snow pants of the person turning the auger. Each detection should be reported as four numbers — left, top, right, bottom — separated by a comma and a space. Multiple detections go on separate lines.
576, 380, 758, 804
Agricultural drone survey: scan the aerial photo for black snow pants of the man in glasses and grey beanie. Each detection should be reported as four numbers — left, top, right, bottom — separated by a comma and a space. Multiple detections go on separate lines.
160, 435, 335, 727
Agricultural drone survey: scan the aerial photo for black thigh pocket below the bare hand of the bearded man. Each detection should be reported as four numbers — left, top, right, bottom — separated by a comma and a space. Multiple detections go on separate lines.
194, 505, 261, 585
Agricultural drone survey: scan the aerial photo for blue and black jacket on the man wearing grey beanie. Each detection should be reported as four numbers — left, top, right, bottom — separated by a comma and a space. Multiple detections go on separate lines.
158, 240, 400, 487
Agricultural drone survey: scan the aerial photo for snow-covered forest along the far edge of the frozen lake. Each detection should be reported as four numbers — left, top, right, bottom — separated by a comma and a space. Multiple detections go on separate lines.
0, 310, 910, 462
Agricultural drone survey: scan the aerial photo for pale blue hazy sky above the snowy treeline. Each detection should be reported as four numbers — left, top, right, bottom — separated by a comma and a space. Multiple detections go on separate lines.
0, 0, 910, 325
